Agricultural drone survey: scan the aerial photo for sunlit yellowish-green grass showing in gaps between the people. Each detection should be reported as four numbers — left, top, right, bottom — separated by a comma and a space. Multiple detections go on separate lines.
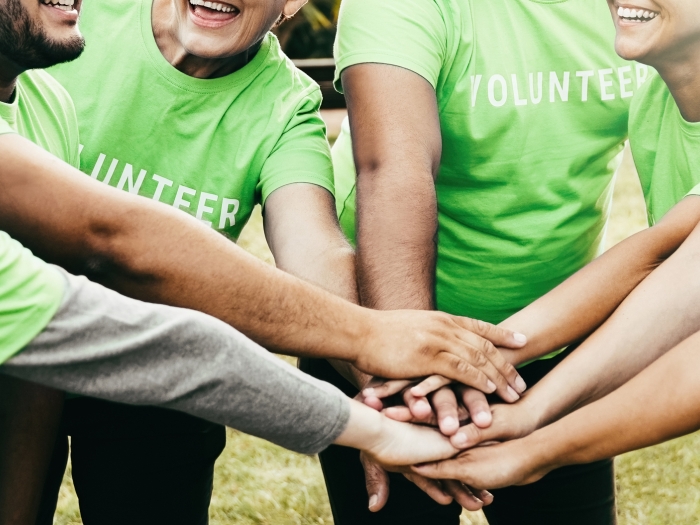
56, 144, 700, 525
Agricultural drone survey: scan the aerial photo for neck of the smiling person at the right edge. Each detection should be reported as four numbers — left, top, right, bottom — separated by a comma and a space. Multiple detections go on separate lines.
654, 50, 700, 122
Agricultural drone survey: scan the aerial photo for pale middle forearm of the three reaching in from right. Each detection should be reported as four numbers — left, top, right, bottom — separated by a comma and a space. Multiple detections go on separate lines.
524, 219, 700, 425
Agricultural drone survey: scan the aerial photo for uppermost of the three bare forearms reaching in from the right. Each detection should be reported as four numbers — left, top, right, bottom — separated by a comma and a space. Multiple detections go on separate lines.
502, 197, 700, 365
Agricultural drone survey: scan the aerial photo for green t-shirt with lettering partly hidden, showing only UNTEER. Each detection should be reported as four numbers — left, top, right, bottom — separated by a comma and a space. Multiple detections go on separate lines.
50, 0, 333, 239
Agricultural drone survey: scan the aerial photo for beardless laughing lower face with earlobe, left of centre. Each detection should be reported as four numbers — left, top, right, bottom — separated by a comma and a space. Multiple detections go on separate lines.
165, 0, 307, 58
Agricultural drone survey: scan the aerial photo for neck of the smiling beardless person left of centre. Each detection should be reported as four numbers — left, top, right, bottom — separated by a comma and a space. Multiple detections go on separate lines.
151, 0, 262, 79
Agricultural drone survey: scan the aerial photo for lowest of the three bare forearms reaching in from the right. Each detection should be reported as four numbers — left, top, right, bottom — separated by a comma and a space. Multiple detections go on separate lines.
526, 328, 700, 470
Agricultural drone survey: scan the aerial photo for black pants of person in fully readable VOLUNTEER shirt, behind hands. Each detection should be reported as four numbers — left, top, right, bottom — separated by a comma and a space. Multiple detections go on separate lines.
300, 352, 615, 525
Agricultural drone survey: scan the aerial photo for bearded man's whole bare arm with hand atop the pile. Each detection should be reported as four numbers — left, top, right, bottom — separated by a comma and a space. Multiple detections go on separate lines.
0, 135, 524, 391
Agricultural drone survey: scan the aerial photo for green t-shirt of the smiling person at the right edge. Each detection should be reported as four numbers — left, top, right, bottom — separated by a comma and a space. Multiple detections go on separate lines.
630, 73, 700, 225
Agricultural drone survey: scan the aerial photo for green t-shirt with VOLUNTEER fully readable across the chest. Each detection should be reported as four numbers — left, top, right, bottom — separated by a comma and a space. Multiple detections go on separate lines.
333, 0, 647, 322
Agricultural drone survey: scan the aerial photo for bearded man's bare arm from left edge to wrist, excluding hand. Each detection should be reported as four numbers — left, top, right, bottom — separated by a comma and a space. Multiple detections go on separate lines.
0, 136, 368, 360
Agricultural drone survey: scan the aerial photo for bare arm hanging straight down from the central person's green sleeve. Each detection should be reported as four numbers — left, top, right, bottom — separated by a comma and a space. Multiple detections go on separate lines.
342, 64, 442, 310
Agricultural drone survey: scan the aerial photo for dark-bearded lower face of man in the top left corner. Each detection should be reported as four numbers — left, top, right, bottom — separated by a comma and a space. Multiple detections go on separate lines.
0, 0, 85, 69
